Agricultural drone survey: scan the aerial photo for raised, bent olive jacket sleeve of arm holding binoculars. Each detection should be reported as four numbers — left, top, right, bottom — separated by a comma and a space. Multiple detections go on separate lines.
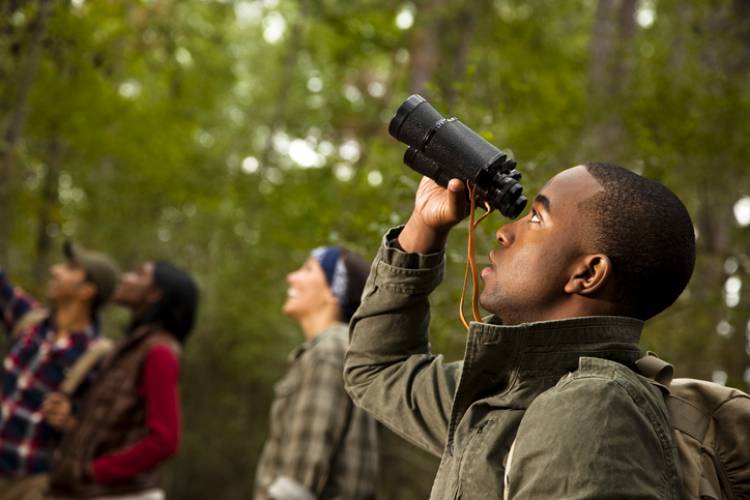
344, 229, 461, 456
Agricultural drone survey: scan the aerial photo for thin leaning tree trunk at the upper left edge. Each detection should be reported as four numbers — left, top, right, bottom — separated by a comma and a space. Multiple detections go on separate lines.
0, 0, 52, 264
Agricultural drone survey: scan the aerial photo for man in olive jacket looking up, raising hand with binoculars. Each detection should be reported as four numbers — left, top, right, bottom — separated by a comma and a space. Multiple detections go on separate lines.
344, 97, 695, 500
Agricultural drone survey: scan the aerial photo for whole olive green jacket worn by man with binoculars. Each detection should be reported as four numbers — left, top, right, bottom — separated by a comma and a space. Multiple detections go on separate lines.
344, 230, 679, 500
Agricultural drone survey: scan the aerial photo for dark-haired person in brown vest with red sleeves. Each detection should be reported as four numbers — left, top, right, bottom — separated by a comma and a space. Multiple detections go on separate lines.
44, 261, 198, 500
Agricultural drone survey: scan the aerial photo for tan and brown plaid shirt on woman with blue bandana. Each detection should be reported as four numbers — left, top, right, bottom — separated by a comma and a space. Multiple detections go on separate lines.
255, 323, 378, 500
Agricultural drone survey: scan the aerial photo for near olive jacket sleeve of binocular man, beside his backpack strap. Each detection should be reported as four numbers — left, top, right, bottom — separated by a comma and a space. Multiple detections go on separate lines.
505, 375, 677, 500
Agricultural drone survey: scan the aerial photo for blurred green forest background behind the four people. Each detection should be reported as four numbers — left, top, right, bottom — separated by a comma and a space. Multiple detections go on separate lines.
0, 0, 750, 499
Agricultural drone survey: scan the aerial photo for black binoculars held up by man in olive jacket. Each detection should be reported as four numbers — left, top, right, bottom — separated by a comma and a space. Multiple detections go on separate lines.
388, 94, 526, 219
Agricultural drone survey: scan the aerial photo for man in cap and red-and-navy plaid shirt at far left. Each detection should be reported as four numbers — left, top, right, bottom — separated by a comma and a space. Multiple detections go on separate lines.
0, 243, 118, 500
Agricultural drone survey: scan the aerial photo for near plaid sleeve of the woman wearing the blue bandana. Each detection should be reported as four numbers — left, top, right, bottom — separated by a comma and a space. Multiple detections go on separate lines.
280, 349, 352, 496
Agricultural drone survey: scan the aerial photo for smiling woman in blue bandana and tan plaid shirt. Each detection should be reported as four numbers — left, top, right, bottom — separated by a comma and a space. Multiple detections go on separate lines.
255, 246, 378, 500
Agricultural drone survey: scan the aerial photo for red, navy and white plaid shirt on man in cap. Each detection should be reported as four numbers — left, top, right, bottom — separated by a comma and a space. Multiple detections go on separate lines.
0, 269, 98, 477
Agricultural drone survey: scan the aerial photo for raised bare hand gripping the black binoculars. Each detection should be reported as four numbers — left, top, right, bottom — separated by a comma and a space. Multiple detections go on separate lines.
398, 177, 469, 254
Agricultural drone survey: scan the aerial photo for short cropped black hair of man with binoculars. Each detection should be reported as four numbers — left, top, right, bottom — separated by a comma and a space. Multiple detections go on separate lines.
581, 163, 695, 320
